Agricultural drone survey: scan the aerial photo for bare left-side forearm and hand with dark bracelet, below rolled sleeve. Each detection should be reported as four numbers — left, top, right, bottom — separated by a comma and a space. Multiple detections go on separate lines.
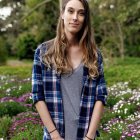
35, 101, 63, 140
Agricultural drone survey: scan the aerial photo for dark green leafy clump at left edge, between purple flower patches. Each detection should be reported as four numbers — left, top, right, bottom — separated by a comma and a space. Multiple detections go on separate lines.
0, 101, 27, 117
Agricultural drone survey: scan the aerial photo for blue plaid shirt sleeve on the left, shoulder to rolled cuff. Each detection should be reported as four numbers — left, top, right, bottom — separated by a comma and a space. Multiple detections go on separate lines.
32, 47, 45, 104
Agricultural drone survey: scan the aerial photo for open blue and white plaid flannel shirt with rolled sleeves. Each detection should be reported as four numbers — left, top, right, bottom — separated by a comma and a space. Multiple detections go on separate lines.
32, 42, 107, 140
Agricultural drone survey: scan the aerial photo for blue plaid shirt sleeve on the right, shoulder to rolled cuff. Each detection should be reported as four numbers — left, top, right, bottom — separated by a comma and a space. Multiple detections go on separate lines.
96, 51, 108, 105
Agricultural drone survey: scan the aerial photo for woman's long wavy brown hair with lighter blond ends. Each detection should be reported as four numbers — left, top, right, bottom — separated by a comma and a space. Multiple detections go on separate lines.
44, 0, 99, 79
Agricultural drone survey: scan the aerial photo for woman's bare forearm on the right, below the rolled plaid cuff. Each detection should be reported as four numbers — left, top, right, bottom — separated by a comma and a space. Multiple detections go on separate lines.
85, 101, 104, 140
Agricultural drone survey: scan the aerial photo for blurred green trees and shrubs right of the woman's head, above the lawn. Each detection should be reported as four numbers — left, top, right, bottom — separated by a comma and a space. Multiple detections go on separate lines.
90, 0, 140, 57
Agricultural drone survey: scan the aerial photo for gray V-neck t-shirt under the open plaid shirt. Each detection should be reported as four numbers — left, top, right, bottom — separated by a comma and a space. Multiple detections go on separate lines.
61, 64, 83, 140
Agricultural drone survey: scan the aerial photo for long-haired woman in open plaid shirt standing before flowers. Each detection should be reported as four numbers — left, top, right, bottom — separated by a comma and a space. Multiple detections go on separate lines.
32, 0, 107, 140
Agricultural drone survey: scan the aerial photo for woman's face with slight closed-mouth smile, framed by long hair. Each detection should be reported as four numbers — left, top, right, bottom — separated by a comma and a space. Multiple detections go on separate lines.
62, 0, 85, 34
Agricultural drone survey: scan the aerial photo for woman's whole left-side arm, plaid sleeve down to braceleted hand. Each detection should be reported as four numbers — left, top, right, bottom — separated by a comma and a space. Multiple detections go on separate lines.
32, 47, 63, 140
